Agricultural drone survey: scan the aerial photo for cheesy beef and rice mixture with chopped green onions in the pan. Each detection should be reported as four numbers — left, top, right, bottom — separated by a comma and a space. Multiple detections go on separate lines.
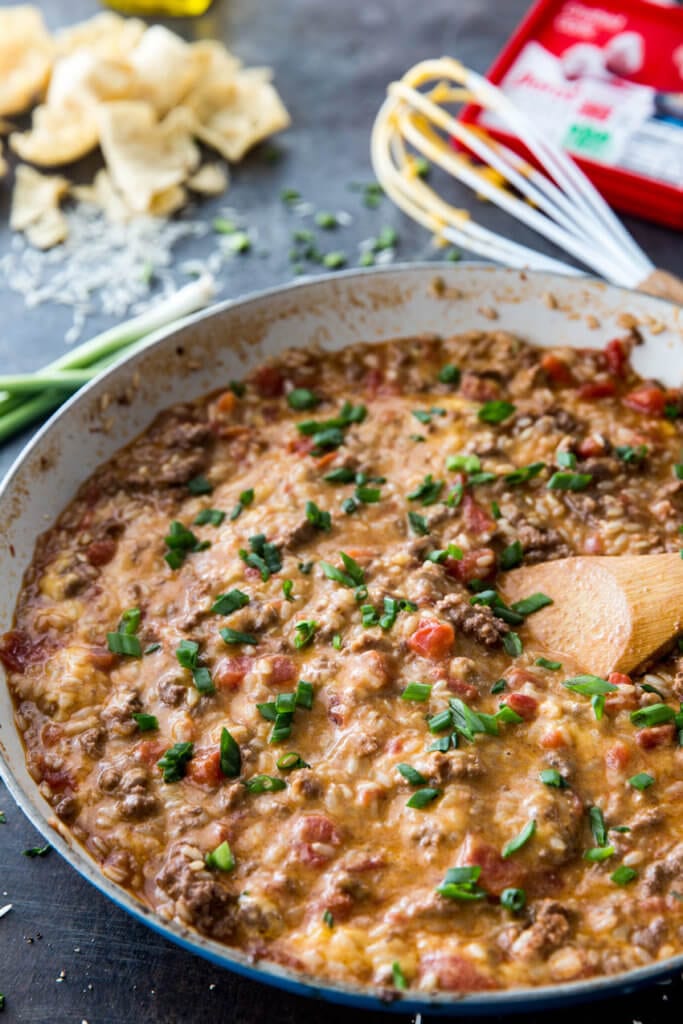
1, 331, 683, 993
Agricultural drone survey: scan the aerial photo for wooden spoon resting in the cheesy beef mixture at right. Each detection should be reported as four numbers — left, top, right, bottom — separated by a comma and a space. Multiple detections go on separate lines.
500, 554, 683, 677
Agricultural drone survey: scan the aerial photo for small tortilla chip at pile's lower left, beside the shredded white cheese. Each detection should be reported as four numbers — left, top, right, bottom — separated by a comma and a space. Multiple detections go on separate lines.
9, 164, 69, 249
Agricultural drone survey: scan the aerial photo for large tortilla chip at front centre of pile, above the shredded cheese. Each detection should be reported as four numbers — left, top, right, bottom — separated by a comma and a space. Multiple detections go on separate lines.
98, 102, 200, 213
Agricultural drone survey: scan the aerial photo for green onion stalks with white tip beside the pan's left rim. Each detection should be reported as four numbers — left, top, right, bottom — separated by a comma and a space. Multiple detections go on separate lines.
0, 273, 214, 442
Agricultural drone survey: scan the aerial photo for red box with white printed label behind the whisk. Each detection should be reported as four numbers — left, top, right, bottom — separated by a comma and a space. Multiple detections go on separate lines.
460, 0, 683, 230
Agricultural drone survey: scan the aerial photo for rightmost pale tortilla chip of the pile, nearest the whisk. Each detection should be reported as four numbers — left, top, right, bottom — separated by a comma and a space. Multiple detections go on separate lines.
185, 68, 290, 162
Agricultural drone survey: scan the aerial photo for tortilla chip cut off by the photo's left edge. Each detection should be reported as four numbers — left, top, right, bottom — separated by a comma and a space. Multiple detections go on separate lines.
0, 6, 53, 115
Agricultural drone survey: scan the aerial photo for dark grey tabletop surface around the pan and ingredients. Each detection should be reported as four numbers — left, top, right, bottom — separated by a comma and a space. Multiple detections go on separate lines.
0, 0, 683, 1024
